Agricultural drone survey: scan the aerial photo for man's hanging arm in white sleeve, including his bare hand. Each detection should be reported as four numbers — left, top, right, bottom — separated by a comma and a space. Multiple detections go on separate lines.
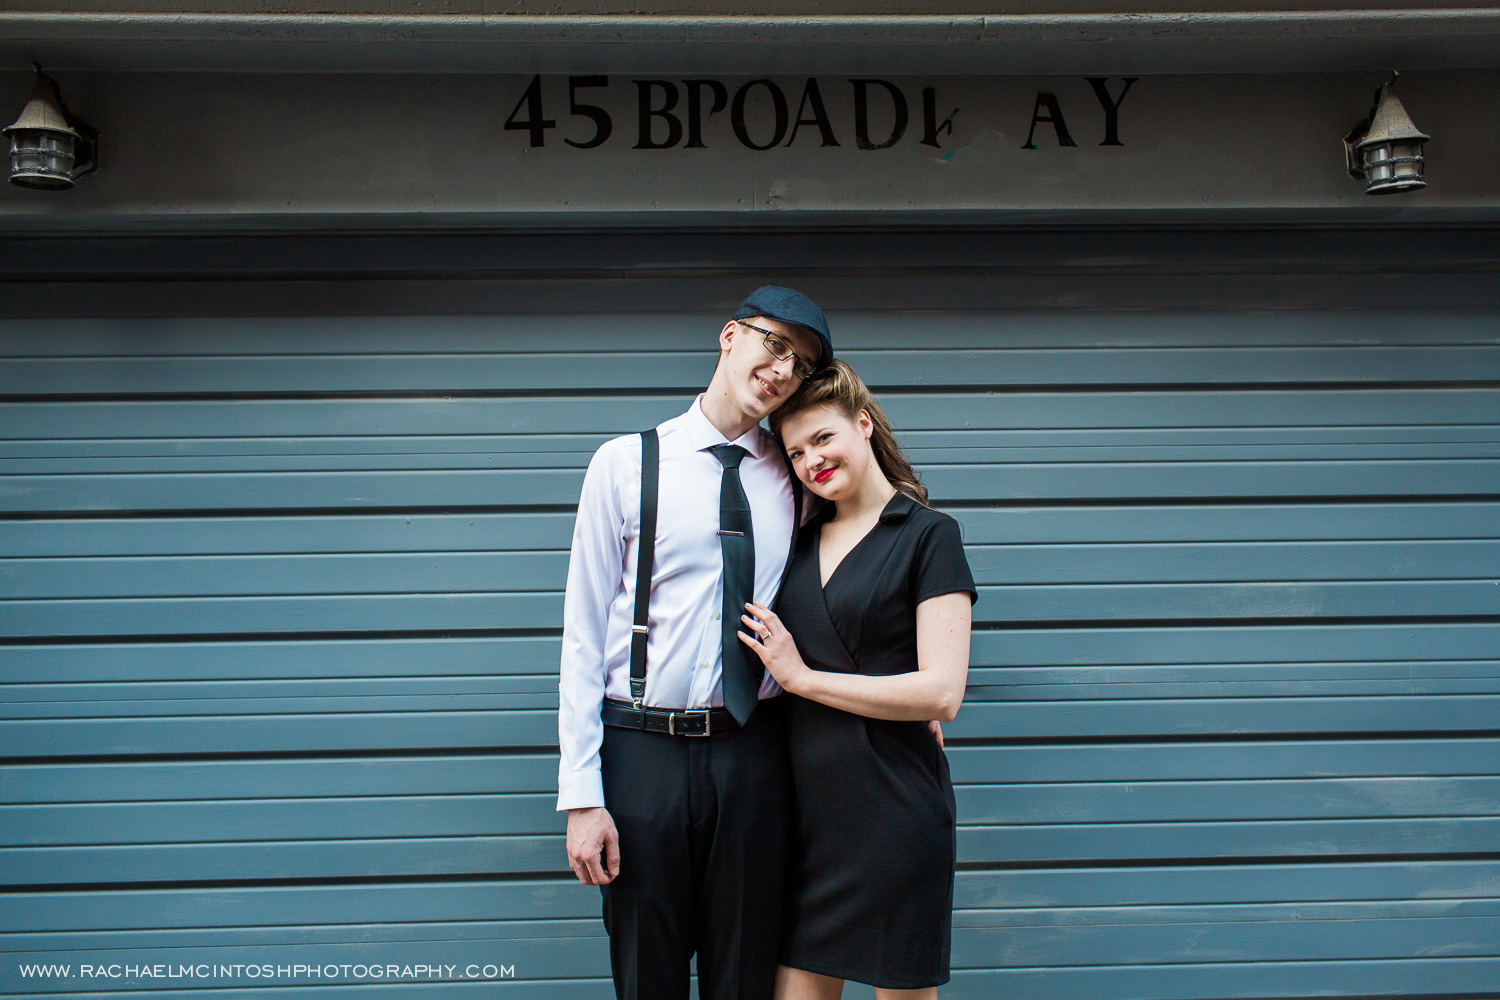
558, 445, 626, 885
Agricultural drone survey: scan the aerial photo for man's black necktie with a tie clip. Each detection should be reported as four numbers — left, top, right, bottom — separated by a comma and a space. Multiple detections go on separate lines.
710, 444, 765, 726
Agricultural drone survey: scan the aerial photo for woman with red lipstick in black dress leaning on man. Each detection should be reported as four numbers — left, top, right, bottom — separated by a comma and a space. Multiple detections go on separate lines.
740, 361, 978, 1000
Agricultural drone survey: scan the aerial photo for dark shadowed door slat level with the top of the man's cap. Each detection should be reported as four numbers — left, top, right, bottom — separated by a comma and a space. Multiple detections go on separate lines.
11, 269, 1500, 322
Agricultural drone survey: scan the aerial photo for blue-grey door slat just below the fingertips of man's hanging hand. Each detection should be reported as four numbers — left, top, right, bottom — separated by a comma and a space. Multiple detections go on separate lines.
0, 859, 1500, 940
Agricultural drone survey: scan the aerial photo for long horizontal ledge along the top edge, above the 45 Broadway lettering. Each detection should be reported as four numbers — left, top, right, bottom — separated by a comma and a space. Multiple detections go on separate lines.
0, 7, 1500, 75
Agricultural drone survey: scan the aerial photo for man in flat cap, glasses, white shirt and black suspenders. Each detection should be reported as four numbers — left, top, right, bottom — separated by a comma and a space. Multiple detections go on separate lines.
558, 285, 833, 1000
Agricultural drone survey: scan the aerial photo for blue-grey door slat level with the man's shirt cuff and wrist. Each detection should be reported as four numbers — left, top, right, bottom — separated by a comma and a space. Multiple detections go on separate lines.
0, 775, 1500, 849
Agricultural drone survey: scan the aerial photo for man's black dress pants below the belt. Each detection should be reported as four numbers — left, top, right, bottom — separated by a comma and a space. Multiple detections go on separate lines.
600, 706, 791, 1000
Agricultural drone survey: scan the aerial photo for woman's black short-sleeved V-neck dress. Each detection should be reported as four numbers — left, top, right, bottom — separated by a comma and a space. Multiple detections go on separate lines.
776, 493, 978, 990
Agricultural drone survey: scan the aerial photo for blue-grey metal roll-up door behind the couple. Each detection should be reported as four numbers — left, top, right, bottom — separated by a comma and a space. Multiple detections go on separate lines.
0, 232, 1500, 1000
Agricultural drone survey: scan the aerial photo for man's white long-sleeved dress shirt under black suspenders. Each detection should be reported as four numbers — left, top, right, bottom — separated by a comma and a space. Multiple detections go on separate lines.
558, 396, 794, 810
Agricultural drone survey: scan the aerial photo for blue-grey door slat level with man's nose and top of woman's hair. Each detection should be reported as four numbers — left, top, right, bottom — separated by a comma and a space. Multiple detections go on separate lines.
11, 341, 1500, 396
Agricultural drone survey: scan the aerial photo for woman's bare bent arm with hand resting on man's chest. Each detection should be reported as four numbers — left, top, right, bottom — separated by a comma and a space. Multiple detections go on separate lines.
740, 592, 972, 723
